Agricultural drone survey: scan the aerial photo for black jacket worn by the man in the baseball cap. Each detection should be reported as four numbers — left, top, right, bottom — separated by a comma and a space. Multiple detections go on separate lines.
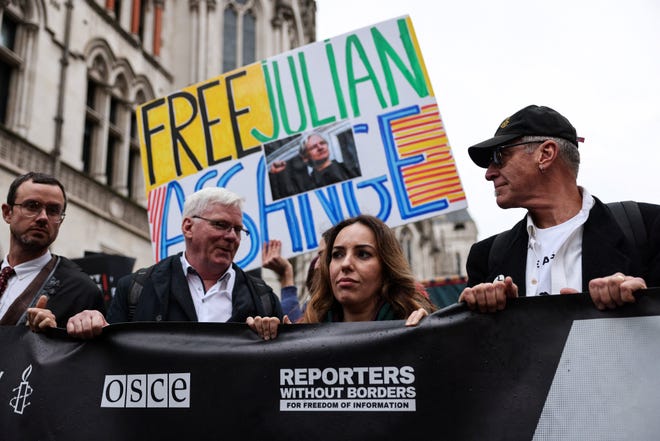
466, 198, 660, 297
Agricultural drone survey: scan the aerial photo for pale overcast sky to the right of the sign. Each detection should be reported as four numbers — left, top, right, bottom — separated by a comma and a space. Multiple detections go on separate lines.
316, 0, 660, 239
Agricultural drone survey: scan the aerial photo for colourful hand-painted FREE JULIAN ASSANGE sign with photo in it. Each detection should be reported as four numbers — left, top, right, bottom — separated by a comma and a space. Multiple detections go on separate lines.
137, 17, 467, 268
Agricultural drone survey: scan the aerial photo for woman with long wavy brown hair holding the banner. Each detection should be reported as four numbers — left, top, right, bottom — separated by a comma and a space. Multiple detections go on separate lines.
247, 215, 435, 340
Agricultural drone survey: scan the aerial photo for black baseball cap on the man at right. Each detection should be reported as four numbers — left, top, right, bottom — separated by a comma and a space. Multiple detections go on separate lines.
468, 105, 582, 168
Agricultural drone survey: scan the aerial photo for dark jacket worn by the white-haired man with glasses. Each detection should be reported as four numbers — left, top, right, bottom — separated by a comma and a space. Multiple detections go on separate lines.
107, 254, 282, 323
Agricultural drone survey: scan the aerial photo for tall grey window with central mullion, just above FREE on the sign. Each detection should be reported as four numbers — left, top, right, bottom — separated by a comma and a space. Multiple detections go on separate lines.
222, 0, 257, 72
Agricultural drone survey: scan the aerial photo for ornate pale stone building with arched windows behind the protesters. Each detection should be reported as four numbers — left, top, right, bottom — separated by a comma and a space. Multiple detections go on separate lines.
0, 0, 476, 300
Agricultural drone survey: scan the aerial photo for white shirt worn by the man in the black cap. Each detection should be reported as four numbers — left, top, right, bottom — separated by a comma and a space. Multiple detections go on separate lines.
526, 187, 594, 296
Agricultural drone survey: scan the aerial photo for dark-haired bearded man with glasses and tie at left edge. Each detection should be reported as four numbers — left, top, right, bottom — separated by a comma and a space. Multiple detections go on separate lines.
0, 172, 104, 326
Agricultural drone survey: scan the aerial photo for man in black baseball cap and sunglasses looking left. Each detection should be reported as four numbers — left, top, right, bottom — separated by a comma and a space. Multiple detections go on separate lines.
459, 106, 660, 312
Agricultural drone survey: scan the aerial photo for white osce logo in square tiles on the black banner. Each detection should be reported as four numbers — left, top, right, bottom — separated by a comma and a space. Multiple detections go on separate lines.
101, 373, 190, 408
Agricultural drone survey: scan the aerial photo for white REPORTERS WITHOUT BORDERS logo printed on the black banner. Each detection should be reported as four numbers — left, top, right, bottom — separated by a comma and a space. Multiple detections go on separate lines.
280, 366, 417, 412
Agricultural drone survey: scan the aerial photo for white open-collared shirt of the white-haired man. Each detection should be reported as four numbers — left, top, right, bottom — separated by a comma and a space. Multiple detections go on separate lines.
181, 253, 236, 323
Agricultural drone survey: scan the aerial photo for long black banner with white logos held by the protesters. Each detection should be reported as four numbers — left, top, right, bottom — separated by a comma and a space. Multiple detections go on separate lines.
0, 289, 660, 441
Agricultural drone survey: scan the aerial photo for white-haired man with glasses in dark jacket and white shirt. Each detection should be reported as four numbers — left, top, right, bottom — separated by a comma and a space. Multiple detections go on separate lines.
29, 187, 282, 338
